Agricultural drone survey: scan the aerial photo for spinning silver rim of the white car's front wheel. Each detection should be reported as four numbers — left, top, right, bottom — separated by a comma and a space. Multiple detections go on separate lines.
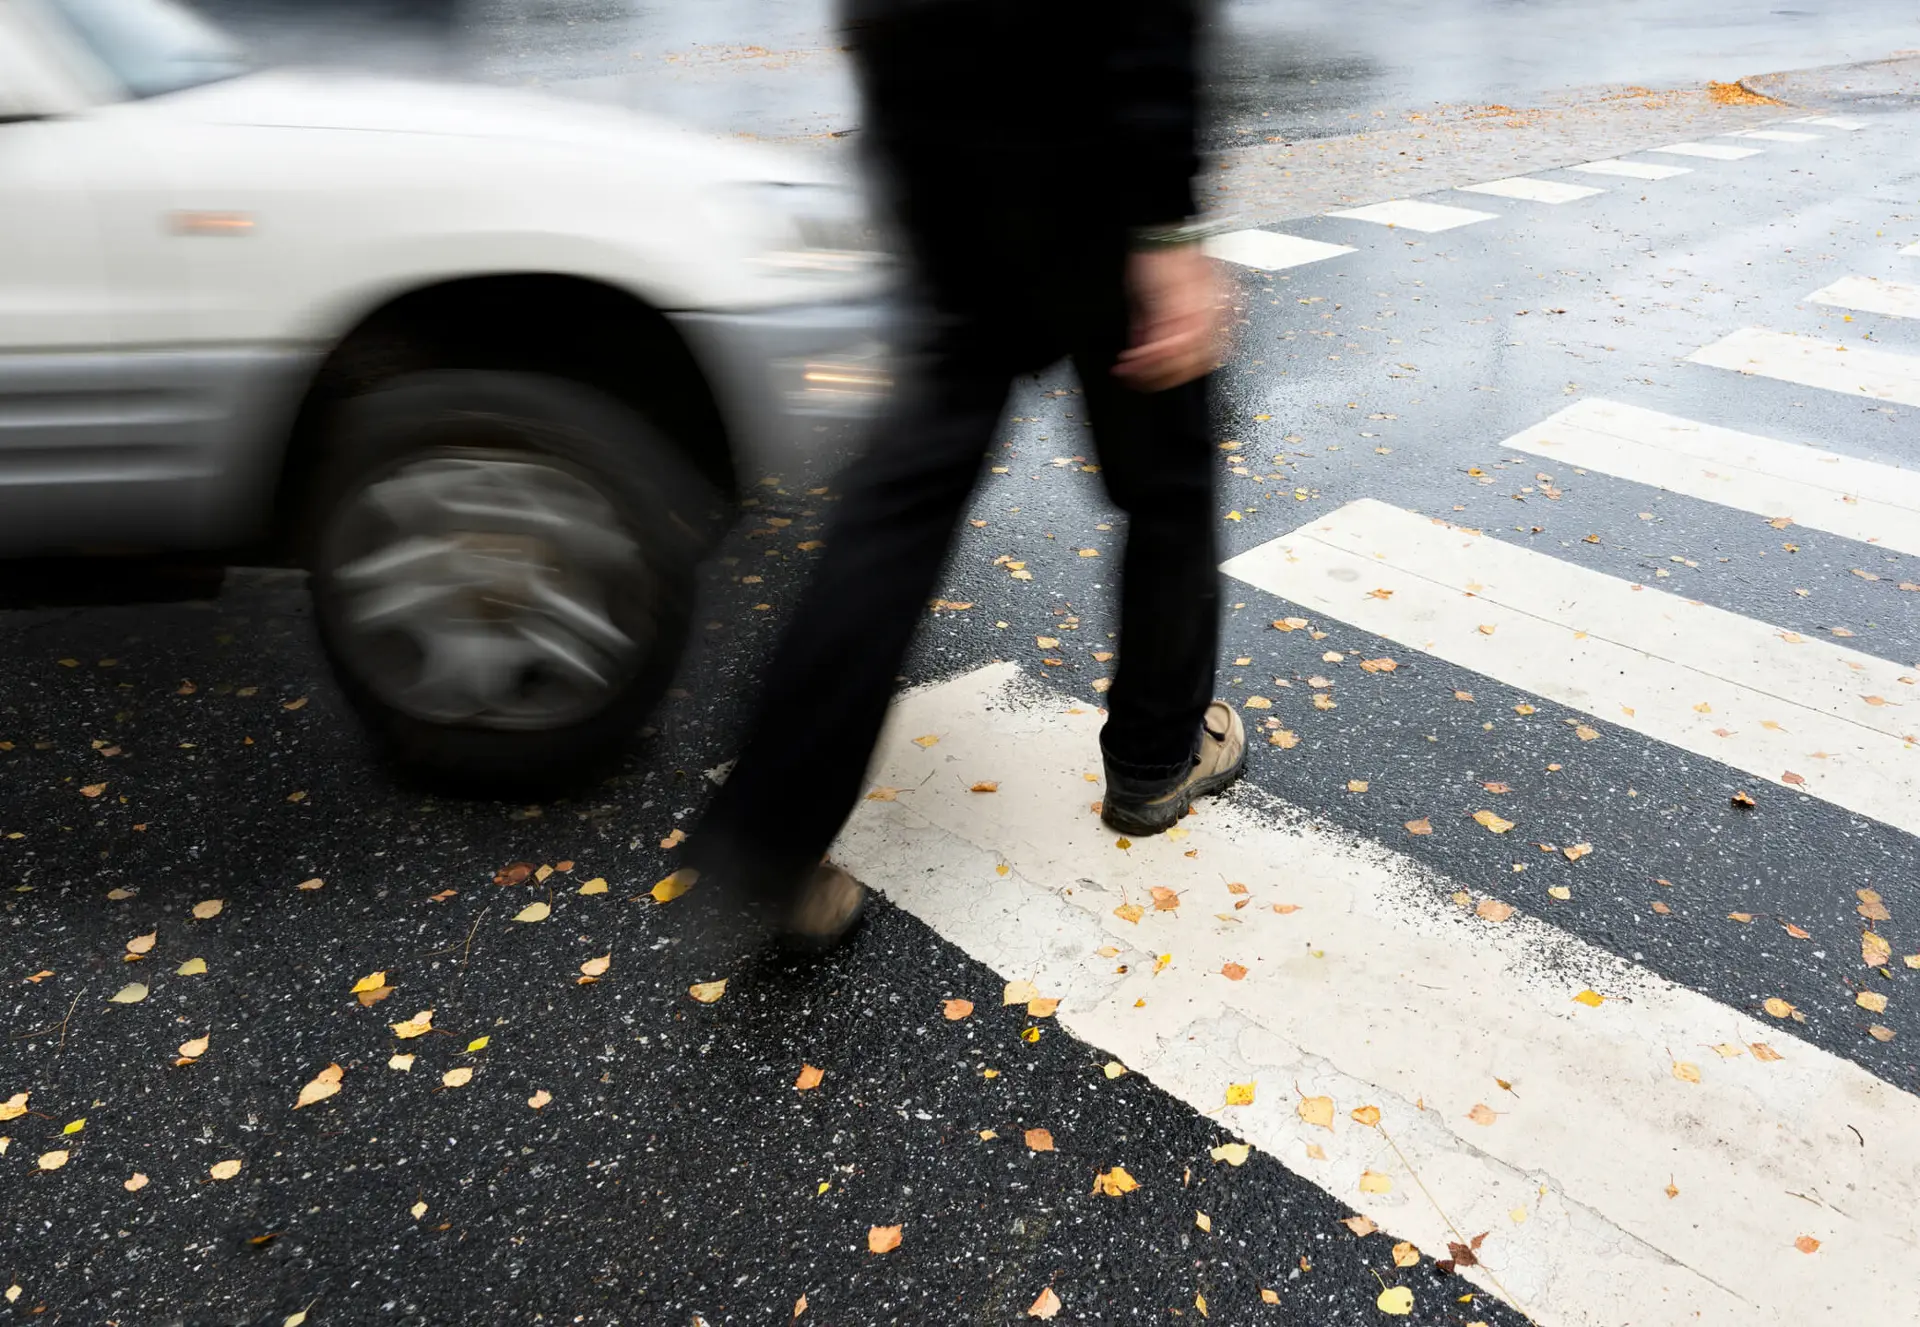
323, 451, 659, 730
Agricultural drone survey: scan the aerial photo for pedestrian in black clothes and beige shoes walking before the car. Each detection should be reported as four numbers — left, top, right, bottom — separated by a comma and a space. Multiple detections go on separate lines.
689, 0, 1246, 947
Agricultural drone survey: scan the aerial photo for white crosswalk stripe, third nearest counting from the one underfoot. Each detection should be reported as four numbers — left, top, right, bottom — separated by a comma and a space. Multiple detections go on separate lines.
1501, 399, 1920, 560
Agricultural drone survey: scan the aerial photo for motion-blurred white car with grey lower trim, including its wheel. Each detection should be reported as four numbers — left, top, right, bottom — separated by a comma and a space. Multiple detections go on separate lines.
0, 0, 887, 789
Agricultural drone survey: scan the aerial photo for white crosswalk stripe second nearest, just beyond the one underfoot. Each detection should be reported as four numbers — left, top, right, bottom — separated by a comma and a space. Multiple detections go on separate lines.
1223, 499, 1920, 833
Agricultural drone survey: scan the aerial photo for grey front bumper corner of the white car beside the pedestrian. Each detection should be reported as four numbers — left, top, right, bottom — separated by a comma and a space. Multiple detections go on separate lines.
670, 302, 895, 484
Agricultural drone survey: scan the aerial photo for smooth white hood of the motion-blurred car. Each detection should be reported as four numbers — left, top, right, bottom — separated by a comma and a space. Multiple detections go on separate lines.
155, 69, 845, 182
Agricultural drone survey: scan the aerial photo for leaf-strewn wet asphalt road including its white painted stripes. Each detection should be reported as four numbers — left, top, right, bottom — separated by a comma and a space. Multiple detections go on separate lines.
0, 10, 1920, 1327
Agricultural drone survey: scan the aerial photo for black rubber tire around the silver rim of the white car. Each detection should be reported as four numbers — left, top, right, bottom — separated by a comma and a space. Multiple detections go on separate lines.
307, 371, 710, 797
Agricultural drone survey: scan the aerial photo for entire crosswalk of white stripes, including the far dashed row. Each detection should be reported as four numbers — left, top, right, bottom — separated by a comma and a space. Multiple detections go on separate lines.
835, 108, 1920, 1327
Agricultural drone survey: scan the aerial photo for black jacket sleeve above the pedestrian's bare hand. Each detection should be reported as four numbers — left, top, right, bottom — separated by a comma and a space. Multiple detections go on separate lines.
1106, 0, 1200, 227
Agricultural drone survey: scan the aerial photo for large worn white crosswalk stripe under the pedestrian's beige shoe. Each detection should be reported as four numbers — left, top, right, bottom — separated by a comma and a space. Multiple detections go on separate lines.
833, 664, 1920, 1327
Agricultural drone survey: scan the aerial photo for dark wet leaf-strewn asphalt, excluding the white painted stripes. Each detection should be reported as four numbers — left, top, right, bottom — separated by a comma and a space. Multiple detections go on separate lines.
0, 10, 1920, 1327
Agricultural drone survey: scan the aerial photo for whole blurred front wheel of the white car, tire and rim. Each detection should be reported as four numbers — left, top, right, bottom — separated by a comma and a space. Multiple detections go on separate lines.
309, 371, 699, 795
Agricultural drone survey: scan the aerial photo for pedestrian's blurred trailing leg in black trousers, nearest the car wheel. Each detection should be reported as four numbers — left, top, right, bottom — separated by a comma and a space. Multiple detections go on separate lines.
687, 337, 1008, 905
